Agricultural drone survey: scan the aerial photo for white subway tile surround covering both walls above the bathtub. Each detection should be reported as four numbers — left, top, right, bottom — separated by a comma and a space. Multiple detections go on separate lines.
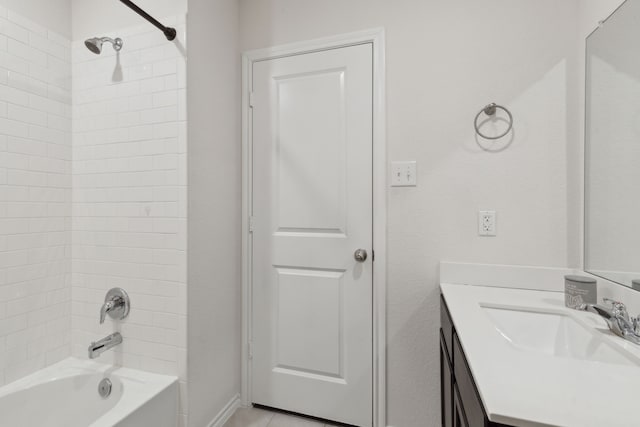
0, 8, 187, 423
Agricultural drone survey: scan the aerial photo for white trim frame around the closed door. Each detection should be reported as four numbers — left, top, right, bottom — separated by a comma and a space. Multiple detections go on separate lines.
240, 28, 387, 427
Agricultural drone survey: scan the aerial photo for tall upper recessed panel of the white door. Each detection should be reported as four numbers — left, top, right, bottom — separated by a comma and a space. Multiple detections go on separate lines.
274, 69, 347, 234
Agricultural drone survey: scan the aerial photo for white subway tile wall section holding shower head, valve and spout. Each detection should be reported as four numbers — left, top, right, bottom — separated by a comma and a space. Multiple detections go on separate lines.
71, 16, 187, 423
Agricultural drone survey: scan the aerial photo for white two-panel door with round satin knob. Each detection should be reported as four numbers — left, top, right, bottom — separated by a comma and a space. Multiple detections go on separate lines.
252, 44, 373, 427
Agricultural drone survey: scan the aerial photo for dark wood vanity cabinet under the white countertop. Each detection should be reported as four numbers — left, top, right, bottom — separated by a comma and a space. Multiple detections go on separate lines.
440, 296, 510, 427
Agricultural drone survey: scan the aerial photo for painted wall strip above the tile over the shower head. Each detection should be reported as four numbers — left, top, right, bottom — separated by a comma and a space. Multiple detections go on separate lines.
73, 0, 187, 40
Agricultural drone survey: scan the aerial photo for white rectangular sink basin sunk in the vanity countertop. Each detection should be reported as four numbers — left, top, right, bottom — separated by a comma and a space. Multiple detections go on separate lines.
481, 304, 640, 366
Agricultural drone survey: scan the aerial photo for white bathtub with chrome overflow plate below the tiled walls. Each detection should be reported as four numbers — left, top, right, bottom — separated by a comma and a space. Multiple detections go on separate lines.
0, 358, 178, 427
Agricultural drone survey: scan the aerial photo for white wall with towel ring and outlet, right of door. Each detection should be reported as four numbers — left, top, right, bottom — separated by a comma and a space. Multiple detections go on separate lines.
241, 0, 579, 427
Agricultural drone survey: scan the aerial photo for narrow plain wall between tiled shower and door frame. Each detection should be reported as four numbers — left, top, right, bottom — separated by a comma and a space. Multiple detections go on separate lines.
188, 0, 241, 427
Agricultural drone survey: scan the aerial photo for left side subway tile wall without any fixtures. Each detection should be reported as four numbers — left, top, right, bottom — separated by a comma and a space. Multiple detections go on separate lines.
0, 7, 71, 385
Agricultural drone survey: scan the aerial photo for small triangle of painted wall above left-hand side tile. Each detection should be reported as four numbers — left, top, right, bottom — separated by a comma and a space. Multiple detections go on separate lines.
0, 0, 72, 38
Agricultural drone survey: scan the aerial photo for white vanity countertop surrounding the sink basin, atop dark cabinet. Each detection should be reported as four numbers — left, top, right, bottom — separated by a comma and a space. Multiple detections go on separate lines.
440, 284, 640, 427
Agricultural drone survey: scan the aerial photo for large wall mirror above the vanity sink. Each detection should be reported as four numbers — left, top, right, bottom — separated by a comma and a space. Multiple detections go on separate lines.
584, 0, 640, 290
